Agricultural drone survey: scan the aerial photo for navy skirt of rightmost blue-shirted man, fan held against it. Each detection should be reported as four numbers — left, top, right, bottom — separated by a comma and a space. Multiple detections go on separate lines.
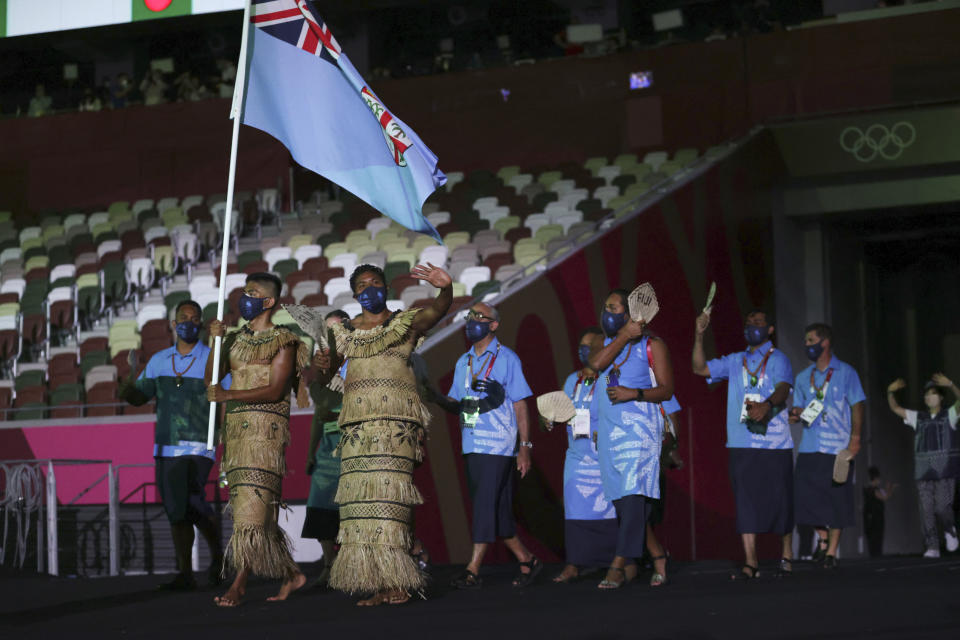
796, 453, 855, 529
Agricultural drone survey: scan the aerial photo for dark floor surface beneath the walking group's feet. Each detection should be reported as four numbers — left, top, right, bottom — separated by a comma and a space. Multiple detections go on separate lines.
0, 557, 960, 640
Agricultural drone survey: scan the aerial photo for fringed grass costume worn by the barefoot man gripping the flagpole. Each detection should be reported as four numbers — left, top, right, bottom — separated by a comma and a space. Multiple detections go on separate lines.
221, 327, 309, 580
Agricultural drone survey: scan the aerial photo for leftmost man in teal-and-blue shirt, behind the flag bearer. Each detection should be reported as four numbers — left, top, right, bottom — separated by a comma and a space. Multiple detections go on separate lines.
119, 300, 223, 590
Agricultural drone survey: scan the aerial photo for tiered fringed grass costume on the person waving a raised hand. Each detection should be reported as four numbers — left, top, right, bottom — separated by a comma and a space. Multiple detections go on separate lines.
330, 309, 430, 594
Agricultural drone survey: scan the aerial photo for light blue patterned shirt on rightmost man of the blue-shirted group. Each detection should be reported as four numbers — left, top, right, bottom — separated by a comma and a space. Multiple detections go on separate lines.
793, 356, 867, 455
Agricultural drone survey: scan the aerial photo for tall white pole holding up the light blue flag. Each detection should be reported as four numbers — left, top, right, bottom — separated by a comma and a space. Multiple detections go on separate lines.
207, 0, 250, 451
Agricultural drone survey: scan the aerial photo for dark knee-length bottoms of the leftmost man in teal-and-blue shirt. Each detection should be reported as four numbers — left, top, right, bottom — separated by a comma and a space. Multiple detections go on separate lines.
154, 456, 213, 524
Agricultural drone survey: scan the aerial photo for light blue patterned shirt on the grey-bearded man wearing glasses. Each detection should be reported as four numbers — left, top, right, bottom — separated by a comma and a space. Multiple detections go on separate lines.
449, 338, 533, 456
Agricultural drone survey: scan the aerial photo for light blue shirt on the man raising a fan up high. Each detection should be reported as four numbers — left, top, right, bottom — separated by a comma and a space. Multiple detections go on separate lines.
707, 340, 793, 449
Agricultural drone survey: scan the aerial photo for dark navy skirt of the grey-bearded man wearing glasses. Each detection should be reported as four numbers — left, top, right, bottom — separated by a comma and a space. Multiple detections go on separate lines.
463, 453, 517, 544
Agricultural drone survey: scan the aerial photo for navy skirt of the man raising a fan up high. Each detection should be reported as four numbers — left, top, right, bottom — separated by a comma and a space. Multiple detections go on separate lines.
727, 449, 793, 535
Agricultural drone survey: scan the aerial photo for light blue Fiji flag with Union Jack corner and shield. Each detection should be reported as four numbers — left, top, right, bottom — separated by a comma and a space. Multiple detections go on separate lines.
241, 0, 447, 240
